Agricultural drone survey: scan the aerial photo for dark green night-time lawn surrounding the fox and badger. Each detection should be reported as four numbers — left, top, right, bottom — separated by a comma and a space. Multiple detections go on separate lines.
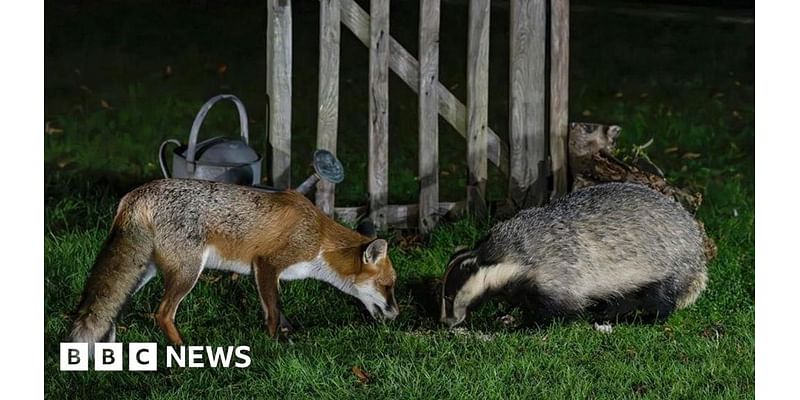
44, 1, 755, 398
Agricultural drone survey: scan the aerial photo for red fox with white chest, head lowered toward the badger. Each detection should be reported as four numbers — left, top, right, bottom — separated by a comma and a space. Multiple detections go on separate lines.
70, 179, 399, 353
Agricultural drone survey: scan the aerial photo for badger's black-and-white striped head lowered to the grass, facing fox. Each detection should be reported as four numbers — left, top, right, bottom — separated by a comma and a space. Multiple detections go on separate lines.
441, 249, 519, 328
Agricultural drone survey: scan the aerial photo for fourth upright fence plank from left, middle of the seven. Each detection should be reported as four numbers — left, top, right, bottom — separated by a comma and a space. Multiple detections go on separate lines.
418, 0, 440, 233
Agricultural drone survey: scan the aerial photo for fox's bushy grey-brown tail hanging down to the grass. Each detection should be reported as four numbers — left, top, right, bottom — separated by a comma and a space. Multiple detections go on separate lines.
70, 224, 154, 354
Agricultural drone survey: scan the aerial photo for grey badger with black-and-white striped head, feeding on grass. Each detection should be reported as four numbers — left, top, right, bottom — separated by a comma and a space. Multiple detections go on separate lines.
442, 183, 707, 327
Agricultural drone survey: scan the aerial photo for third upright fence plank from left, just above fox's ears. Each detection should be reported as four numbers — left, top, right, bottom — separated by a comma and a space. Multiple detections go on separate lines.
367, 0, 389, 229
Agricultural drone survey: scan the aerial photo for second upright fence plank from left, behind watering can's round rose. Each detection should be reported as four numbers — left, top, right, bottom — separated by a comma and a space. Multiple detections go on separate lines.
315, 0, 341, 216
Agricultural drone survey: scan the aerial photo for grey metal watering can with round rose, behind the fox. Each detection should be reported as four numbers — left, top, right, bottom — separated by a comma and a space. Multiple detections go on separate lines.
158, 94, 344, 194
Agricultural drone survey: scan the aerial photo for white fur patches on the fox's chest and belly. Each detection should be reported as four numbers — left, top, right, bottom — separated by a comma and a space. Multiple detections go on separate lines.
202, 246, 340, 286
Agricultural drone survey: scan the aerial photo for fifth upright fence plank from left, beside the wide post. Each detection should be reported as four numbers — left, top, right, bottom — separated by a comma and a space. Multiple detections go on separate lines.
467, 0, 490, 216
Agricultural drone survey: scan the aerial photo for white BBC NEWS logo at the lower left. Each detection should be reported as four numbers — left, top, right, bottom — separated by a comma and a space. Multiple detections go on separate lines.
60, 343, 251, 371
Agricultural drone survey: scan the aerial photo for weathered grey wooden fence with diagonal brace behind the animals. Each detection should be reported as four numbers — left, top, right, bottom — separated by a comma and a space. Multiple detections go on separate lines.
267, 0, 569, 232
